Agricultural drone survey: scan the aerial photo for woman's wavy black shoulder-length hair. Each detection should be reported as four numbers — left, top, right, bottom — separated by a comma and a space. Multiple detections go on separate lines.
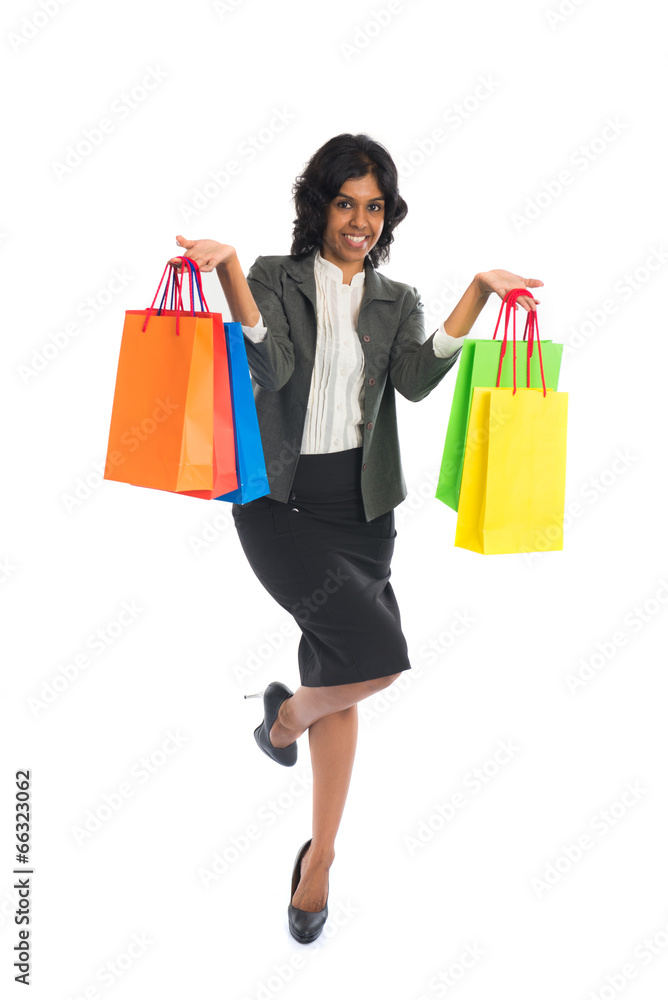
290, 132, 408, 267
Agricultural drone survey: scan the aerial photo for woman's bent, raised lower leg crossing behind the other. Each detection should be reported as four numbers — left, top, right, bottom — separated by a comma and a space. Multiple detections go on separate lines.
269, 674, 399, 747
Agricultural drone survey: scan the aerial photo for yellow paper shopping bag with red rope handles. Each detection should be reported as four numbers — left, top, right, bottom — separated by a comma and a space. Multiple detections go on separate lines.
454, 290, 568, 555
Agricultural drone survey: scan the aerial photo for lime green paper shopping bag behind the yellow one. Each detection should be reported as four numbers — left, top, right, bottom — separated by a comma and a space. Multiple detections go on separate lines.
436, 299, 563, 510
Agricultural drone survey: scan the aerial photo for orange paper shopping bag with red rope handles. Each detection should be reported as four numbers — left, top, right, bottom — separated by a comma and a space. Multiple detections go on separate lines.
104, 256, 236, 495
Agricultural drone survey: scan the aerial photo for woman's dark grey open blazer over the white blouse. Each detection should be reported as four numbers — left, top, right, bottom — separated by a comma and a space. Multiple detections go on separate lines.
244, 249, 459, 521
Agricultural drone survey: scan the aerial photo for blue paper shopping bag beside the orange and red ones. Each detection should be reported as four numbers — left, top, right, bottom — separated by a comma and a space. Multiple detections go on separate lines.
211, 323, 269, 504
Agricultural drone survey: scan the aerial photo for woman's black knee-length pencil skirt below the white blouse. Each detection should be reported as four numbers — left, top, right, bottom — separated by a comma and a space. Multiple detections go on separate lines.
232, 447, 411, 687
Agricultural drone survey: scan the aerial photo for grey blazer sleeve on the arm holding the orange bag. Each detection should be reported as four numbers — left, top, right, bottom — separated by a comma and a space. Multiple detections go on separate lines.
244, 257, 295, 391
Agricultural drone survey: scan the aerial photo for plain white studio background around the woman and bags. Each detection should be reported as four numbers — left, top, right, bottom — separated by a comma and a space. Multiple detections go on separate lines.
0, 0, 668, 1000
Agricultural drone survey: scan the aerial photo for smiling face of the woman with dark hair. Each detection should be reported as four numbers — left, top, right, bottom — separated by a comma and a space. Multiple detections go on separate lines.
322, 173, 385, 273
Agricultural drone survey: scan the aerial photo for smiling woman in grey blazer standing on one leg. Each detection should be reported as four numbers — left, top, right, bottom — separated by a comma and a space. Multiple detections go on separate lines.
170, 134, 543, 943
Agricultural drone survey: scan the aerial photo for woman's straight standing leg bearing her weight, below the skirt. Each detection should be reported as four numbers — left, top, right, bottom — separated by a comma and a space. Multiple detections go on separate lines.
292, 705, 357, 912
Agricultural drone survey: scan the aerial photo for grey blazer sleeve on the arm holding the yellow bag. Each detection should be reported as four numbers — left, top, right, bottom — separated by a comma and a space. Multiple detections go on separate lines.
389, 286, 463, 403
